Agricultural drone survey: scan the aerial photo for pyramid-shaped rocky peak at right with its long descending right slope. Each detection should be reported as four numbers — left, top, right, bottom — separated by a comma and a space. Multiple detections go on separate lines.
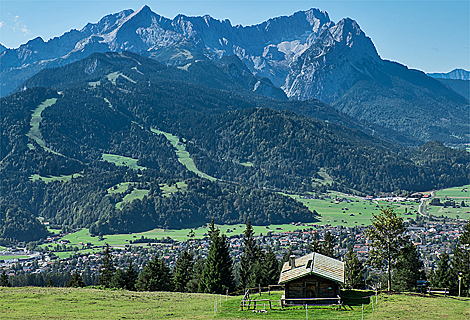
283, 19, 470, 143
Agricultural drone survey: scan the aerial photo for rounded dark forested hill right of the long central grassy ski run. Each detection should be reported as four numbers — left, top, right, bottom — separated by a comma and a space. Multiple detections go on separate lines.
184, 109, 470, 193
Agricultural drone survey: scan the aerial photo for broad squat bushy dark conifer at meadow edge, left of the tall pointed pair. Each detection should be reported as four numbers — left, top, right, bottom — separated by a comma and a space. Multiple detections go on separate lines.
135, 256, 171, 291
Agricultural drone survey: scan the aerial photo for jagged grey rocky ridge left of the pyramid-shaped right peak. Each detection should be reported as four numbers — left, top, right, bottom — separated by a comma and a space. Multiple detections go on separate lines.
0, 6, 331, 95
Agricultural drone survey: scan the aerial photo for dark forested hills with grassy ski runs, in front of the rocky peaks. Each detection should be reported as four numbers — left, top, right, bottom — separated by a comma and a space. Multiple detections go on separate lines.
0, 54, 470, 243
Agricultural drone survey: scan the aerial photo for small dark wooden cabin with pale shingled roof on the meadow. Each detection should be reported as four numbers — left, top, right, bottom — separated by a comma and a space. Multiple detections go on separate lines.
279, 252, 344, 305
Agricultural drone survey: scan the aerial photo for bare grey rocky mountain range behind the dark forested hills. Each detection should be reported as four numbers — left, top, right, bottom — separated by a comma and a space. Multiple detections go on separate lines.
0, 6, 470, 144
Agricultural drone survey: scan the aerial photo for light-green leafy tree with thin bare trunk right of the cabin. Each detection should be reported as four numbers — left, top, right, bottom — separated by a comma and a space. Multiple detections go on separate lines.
365, 208, 407, 291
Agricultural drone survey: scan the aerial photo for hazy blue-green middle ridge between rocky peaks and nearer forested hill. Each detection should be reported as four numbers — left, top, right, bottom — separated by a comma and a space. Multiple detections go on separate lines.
17, 51, 287, 100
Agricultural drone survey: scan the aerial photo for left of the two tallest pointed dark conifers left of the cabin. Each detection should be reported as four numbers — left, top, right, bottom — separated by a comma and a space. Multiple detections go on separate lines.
199, 219, 235, 293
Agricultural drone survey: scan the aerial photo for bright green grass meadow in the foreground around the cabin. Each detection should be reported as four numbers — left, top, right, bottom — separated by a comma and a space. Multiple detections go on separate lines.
0, 287, 470, 320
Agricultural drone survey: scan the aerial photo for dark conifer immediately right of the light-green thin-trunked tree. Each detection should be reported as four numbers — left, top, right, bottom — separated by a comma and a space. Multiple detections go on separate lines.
392, 241, 426, 291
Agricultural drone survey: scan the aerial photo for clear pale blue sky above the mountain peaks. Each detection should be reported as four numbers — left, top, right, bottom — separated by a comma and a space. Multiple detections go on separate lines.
0, 0, 470, 72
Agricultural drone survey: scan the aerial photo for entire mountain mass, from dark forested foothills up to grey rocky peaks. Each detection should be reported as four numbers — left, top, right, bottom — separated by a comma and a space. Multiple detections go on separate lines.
0, 6, 470, 241
